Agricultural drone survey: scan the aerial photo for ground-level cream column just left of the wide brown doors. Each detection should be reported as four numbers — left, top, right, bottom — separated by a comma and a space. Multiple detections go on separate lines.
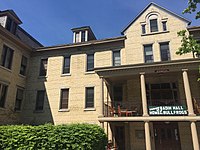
144, 122, 151, 150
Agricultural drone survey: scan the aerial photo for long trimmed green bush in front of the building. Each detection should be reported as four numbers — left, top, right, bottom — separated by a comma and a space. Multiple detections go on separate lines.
0, 124, 107, 150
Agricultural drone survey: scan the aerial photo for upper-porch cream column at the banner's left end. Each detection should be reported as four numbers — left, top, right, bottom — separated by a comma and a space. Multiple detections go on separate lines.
140, 72, 149, 116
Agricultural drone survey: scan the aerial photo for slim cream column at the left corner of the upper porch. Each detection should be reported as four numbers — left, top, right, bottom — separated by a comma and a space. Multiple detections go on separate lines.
99, 78, 104, 117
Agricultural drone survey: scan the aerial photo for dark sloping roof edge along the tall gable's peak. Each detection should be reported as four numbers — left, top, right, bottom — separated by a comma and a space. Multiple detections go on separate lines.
121, 2, 191, 34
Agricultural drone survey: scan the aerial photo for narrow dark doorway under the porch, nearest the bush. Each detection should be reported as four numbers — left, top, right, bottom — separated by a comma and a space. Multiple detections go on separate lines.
115, 126, 125, 150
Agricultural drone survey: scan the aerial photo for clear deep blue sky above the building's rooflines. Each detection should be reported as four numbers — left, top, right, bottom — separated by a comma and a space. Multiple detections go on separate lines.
0, 0, 200, 46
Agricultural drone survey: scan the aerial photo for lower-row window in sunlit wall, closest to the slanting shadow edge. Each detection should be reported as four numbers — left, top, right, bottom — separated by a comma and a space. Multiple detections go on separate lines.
60, 89, 69, 109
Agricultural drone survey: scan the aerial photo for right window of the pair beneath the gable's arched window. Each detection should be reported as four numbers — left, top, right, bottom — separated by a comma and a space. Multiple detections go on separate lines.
160, 42, 170, 61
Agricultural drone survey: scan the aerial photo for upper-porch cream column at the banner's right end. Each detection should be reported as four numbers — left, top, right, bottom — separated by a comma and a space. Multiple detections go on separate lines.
182, 69, 195, 115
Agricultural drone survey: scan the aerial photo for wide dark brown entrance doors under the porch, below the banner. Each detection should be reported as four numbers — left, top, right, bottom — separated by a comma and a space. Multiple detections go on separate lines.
153, 122, 181, 150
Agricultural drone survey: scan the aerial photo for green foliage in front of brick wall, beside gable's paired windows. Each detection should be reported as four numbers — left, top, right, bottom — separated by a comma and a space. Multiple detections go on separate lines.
176, 30, 200, 58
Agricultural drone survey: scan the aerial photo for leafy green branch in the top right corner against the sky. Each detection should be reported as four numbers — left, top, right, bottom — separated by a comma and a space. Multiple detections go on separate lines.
183, 0, 200, 19
